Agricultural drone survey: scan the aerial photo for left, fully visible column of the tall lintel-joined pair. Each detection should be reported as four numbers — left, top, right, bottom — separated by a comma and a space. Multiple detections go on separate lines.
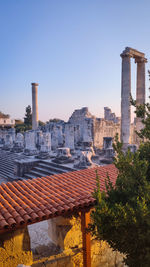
121, 53, 131, 149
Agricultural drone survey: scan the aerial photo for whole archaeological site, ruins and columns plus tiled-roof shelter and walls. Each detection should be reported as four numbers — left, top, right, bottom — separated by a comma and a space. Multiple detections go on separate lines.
0, 47, 147, 267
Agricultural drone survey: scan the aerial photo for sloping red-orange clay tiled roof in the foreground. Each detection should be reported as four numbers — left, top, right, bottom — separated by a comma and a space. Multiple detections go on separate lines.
0, 165, 117, 236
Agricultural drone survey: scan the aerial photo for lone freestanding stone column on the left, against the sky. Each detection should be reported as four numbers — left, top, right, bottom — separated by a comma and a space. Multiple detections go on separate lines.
31, 83, 39, 130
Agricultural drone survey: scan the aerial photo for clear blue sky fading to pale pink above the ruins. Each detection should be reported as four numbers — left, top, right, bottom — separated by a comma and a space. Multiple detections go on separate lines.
0, 0, 150, 121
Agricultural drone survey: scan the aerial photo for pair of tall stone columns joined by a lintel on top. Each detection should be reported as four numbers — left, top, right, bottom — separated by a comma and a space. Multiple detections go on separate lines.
120, 47, 147, 148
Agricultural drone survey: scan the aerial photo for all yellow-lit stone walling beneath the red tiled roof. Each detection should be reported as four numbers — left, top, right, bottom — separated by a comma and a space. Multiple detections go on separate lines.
0, 216, 125, 267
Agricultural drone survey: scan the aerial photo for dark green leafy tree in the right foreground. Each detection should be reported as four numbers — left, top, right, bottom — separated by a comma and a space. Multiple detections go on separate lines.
90, 101, 150, 267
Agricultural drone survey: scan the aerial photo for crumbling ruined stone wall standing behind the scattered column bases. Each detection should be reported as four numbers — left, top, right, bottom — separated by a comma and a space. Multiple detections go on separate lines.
0, 107, 139, 155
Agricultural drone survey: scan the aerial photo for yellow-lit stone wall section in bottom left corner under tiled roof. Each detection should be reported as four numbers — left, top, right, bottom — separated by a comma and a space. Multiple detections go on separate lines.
0, 228, 33, 267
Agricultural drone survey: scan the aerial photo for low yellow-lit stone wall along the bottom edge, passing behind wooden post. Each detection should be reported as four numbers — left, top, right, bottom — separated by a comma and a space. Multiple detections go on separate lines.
32, 243, 125, 267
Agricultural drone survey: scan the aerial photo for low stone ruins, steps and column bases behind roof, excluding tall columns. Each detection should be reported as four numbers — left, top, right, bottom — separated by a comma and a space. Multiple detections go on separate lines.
0, 107, 120, 182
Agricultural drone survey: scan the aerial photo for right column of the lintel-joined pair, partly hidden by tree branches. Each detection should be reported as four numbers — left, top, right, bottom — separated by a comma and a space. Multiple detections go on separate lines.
135, 58, 147, 132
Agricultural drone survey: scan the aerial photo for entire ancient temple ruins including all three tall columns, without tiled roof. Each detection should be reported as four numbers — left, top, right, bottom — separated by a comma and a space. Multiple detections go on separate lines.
0, 47, 147, 185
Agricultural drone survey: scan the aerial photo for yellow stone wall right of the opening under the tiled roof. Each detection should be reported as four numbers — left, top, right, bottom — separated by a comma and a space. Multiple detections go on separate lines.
32, 216, 125, 267
